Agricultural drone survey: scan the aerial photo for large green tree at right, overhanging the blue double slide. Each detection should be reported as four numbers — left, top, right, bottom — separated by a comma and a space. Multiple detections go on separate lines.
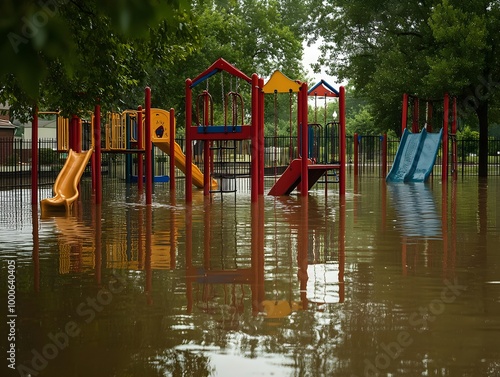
310, 0, 500, 176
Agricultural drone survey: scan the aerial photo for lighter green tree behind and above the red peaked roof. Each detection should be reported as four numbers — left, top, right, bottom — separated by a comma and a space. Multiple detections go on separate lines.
164, 0, 307, 127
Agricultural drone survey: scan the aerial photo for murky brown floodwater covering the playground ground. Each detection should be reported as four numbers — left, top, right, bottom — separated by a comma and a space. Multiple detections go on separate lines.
0, 177, 500, 377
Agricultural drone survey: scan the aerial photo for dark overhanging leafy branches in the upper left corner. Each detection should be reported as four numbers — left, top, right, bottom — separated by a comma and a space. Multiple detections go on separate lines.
0, 0, 195, 117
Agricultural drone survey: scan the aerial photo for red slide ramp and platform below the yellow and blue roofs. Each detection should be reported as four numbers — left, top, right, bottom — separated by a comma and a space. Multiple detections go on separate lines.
268, 158, 339, 196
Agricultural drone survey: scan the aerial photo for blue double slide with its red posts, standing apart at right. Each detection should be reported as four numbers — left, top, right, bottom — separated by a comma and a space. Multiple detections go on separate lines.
386, 94, 457, 182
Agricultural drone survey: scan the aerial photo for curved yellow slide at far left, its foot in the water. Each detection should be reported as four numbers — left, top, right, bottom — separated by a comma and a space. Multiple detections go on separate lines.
40, 149, 92, 215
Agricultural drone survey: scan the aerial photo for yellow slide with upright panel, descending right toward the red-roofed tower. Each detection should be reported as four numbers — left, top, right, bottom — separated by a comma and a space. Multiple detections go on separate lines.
151, 109, 217, 188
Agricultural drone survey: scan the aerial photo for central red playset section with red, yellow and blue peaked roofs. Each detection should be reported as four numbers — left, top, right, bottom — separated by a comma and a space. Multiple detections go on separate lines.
186, 59, 345, 202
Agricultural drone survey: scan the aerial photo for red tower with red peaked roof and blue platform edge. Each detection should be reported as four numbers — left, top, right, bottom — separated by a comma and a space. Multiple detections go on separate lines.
186, 58, 264, 203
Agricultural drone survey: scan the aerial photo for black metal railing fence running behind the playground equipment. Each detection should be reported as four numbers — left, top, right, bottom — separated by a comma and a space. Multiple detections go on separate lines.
0, 135, 500, 189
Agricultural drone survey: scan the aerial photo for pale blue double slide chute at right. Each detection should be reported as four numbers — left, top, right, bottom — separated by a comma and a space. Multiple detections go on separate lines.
386, 129, 443, 182
